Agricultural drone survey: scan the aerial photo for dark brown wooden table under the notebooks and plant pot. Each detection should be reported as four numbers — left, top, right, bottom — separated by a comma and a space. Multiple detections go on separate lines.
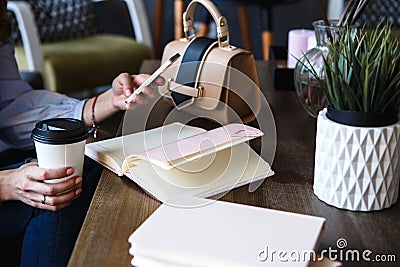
69, 61, 400, 267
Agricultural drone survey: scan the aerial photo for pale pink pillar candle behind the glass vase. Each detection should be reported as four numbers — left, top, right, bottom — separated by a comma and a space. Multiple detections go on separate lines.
287, 29, 315, 69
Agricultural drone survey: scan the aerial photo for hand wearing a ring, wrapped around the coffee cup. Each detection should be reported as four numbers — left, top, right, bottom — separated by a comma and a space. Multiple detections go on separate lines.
0, 162, 82, 211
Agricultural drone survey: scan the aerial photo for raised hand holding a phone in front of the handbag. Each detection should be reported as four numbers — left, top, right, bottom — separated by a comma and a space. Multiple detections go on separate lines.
112, 73, 165, 110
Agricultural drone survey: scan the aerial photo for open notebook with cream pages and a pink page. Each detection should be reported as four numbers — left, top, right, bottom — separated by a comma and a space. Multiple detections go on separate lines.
85, 123, 273, 202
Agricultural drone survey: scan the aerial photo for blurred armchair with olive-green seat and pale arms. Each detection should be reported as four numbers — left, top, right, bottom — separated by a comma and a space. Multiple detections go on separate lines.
8, 0, 153, 94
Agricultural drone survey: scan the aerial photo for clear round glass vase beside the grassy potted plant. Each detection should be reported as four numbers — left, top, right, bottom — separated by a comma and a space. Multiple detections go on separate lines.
294, 20, 342, 118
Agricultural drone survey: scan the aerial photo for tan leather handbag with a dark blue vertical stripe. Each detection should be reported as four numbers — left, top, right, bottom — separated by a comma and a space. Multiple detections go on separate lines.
159, 0, 261, 123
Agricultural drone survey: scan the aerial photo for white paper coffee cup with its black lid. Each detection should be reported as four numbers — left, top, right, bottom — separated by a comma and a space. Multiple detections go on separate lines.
32, 118, 88, 183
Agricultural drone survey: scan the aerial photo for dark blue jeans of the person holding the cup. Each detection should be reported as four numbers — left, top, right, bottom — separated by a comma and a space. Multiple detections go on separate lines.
0, 157, 103, 267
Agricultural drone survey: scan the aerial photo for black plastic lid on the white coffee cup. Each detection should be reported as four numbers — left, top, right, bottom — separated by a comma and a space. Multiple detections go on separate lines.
32, 118, 89, 145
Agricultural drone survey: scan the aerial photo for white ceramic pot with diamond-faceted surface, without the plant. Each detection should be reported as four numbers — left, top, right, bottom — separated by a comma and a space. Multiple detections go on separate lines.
314, 109, 400, 211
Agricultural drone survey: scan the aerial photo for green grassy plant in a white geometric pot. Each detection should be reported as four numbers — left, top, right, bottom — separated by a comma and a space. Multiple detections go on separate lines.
304, 24, 400, 211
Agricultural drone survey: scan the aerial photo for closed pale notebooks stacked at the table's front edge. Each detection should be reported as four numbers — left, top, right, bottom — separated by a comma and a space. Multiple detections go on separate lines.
128, 198, 325, 267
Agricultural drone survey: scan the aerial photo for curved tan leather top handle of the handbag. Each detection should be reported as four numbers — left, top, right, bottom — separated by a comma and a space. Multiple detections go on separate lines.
183, 0, 230, 48
